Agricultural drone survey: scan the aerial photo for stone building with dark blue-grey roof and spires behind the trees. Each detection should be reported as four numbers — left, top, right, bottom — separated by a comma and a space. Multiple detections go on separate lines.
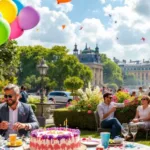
73, 44, 103, 87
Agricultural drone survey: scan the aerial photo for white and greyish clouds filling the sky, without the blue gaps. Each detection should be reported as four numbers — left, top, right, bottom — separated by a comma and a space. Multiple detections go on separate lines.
18, 0, 150, 60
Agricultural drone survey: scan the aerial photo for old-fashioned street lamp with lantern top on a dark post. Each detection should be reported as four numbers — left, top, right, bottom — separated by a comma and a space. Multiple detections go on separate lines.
37, 58, 48, 126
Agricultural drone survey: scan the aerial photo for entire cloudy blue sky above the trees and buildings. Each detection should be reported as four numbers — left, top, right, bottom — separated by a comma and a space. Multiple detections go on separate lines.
17, 0, 150, 61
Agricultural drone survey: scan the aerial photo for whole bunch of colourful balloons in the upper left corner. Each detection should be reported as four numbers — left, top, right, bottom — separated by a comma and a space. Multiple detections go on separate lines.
0, 0, 40, 45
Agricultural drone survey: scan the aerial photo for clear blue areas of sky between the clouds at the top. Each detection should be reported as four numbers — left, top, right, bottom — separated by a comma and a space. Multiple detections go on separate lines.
42, 0, 124, 26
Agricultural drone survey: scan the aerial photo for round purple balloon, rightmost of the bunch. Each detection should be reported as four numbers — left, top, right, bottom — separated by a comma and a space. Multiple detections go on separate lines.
18, 6, 40, 30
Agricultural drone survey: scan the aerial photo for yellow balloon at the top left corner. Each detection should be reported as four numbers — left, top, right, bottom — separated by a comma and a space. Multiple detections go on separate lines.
0, 0, 18, 23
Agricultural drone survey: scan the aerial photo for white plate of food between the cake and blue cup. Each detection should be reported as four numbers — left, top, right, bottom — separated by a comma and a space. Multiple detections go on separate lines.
81, 138, 100, 146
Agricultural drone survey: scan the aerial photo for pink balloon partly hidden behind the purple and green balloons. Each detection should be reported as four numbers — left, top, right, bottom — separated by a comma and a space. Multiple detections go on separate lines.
9, 17, 24, 40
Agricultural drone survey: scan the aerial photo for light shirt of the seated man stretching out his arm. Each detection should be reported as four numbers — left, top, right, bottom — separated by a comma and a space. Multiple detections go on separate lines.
97, 102, 124, 121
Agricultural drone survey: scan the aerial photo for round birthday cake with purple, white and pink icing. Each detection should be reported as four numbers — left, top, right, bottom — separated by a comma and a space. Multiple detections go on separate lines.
30, 127, 81, 150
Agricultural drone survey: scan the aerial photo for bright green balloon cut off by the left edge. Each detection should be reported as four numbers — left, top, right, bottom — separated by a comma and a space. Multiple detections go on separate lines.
0, 17, 10, 45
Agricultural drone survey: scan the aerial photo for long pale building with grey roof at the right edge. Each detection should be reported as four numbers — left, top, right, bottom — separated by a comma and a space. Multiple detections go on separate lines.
114, 57, 150, 86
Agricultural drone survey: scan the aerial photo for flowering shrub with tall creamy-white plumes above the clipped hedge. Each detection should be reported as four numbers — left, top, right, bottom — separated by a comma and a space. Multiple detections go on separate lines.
68, 85, 103, 113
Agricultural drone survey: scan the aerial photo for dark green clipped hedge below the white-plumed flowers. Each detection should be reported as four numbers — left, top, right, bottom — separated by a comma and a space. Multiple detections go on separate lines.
54, 109, 96, 130
